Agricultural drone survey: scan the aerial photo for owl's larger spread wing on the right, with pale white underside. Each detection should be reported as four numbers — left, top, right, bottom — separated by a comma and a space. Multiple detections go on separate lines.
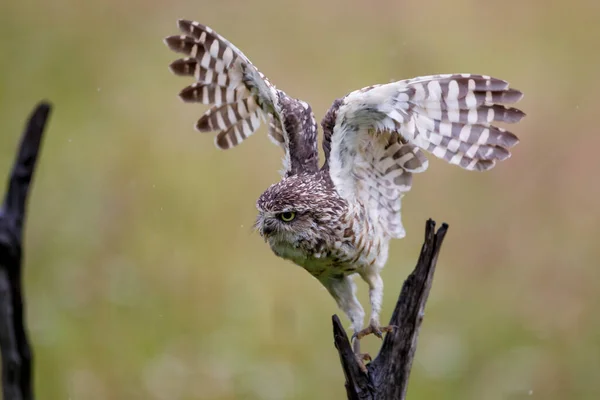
322, 74, 525, 237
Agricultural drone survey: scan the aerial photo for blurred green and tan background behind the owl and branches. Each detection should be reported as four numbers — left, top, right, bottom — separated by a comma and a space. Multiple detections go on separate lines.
0, 0, 600, 400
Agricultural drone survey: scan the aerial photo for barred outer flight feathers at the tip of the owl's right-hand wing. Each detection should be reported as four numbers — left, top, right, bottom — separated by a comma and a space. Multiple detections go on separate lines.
400, 74, 525, 171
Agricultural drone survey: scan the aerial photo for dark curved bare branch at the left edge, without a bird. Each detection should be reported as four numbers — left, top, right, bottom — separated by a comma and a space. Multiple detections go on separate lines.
0, 103, 50, 400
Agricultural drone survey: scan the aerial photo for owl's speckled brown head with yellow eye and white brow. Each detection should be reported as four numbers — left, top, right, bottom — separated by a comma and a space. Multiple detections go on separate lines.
255, 174, 346, 246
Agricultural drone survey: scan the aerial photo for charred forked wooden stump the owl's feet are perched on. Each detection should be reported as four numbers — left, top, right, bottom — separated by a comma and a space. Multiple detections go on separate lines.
333, 219, 448, 400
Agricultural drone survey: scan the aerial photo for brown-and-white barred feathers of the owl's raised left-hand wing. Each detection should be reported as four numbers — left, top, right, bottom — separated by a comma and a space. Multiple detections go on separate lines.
165, 20, 289, 158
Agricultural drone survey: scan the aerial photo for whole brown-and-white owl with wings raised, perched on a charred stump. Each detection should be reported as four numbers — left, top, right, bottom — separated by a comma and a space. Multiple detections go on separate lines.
165, 20, 524, 352
